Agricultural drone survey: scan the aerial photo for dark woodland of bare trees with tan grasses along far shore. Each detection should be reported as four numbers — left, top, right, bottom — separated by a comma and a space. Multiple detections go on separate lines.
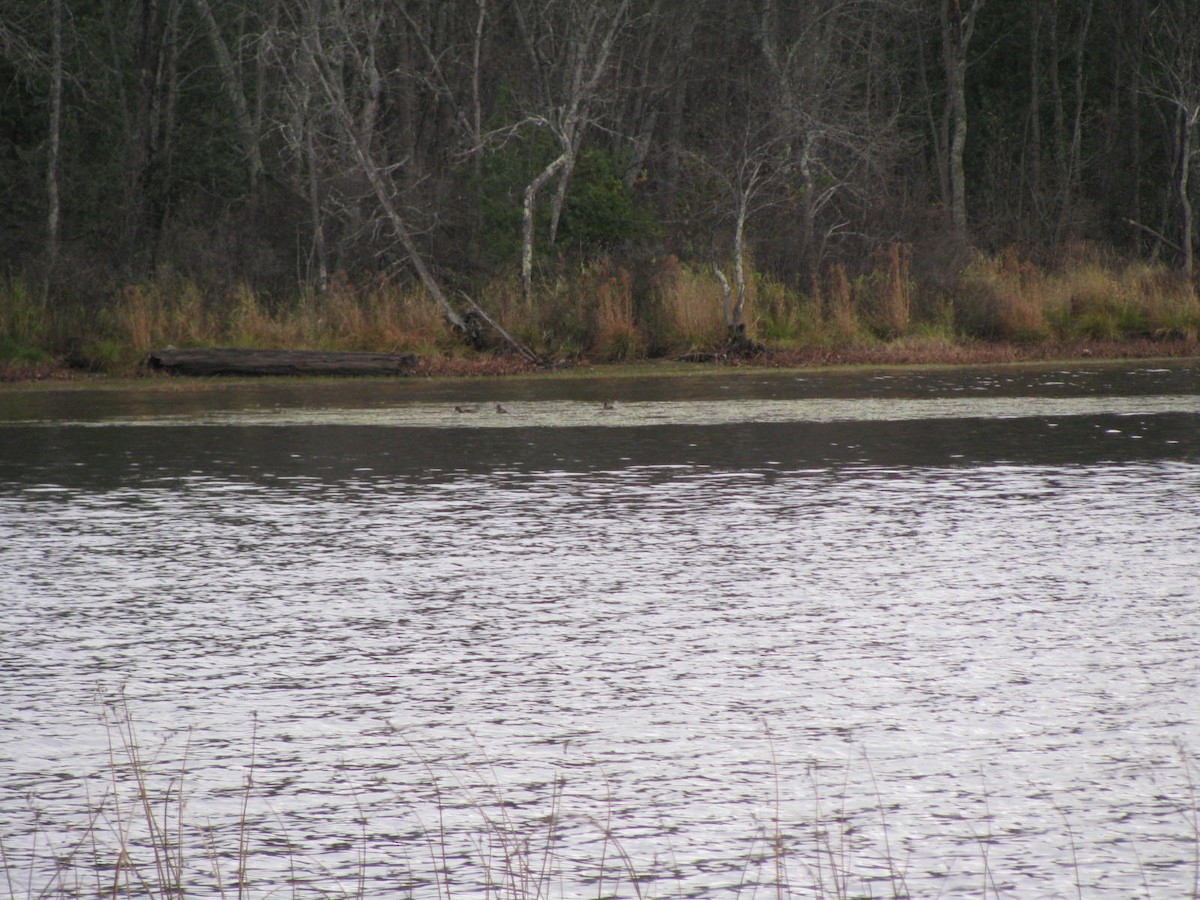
0, 0, 1200, 367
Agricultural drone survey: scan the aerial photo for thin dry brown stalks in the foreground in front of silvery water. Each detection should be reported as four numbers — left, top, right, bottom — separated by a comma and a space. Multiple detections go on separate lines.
0, 708, 1200, 900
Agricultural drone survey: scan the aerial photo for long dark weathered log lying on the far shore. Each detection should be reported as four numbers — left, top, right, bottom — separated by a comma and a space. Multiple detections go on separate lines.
150, 347, 418, 376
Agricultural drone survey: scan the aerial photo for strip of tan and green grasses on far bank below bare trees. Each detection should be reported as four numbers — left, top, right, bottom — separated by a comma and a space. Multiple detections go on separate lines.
0, 246, 1200, 379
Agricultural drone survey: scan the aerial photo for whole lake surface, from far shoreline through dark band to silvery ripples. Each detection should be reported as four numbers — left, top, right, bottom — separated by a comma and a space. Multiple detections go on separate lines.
0, 362, 1200, 898
